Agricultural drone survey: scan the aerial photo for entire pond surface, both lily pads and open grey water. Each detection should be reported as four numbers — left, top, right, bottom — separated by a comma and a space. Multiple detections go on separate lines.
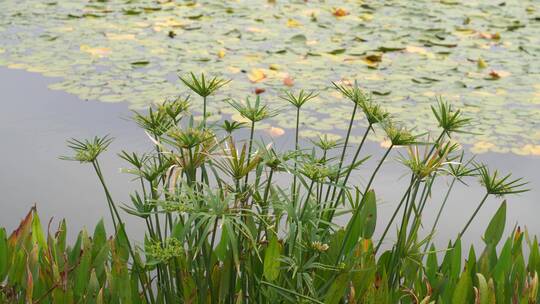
0, 0, 540, 248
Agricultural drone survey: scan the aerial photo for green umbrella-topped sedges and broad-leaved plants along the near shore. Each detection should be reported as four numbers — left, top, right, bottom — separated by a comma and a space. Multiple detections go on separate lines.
0, 74, 540, 304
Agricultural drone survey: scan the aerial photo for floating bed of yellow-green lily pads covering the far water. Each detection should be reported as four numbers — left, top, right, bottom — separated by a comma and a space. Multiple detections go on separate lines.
0, 0, 540, 155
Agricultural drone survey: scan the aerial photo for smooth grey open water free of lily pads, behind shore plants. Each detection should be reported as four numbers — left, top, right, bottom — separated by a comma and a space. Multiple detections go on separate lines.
0, 68, 540, 244
